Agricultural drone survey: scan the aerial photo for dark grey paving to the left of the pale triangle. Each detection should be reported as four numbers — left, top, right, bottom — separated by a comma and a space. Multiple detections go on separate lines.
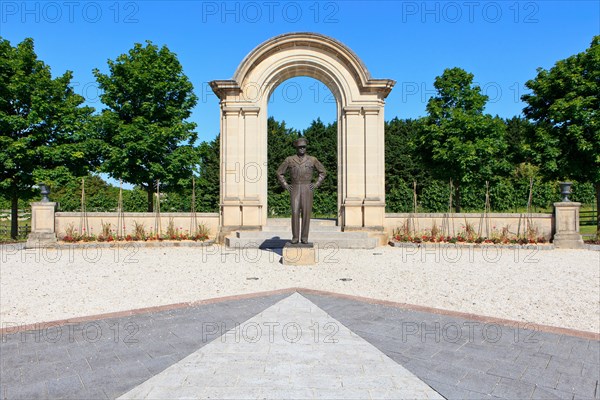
0, 294, 289, 399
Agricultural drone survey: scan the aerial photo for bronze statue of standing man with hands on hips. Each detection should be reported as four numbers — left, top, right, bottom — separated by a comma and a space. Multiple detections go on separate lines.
277, 137, 326, 244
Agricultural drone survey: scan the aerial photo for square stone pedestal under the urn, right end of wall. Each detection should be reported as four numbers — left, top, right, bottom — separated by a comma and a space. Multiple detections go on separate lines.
553, 201, 584, 249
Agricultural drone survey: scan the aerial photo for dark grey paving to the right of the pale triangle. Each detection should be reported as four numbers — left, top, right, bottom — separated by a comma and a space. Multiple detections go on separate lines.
305, 294, 600, 399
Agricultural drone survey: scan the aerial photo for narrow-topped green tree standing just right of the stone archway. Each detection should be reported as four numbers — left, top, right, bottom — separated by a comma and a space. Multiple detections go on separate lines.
420, 68, 510, 212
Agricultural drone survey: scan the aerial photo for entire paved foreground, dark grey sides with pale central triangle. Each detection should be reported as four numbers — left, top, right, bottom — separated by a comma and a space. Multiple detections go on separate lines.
0, 292, 600, 399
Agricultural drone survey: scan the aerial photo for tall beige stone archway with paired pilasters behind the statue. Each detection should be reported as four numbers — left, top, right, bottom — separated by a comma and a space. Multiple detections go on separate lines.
210, 33, 395, 231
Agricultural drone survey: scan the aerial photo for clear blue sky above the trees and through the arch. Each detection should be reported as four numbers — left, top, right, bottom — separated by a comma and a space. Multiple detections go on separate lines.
0, 0, 600, 140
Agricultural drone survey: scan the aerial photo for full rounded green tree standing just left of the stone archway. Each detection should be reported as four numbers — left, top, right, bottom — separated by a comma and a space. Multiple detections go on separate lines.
94, 41, 198, 211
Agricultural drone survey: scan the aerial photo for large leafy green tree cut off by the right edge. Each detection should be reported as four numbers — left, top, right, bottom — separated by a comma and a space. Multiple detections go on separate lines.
522, 36, 600, 235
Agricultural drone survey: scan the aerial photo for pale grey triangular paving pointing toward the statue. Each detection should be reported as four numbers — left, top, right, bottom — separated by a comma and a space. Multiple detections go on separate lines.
119, 293, 443, 399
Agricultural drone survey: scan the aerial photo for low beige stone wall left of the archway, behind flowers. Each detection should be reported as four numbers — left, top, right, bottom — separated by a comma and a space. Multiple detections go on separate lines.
54, 212, 219, 239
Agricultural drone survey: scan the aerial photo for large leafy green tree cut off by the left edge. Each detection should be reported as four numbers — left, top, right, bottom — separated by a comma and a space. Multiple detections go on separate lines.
0, 37, 98, 238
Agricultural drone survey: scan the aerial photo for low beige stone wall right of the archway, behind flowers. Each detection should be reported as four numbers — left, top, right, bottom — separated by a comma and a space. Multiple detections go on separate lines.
385, 213, 554, 240
